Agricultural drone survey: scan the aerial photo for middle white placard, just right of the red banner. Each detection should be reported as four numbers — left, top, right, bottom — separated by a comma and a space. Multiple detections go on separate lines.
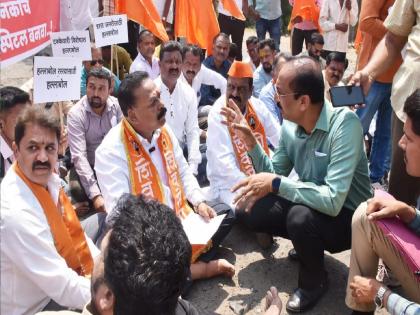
51, 31, 92, 60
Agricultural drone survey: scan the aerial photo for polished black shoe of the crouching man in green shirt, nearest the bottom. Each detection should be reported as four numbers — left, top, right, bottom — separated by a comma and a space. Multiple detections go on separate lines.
286, 280, 328, 313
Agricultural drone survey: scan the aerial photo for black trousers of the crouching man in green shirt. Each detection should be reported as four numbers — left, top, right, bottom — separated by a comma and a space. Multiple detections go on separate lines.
236, 194, 353, 290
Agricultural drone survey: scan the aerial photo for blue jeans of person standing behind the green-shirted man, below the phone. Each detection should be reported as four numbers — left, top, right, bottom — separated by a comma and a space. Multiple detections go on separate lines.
356, 81, 392, 183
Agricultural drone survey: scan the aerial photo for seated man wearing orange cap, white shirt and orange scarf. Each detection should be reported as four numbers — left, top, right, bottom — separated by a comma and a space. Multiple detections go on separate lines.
207, 61, 280, 209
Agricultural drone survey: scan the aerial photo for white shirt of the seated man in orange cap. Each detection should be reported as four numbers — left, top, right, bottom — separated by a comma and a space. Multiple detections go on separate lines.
207, 95, 280, 209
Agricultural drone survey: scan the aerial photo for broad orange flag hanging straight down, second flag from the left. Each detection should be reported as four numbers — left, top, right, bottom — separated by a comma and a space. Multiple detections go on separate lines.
175, 0, 220, 54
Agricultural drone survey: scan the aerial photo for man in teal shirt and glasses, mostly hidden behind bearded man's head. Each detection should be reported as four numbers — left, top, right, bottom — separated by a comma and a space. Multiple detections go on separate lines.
80, 45, 121, 97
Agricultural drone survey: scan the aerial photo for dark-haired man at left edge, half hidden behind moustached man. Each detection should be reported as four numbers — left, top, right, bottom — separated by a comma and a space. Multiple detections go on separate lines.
0, 86, 30, 181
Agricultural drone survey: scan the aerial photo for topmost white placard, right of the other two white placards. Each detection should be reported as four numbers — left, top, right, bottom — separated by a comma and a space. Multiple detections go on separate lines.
93, 14, 128, 47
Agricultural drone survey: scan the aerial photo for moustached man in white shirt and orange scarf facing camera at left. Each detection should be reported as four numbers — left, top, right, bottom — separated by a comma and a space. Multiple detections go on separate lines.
0, 106, 98, 315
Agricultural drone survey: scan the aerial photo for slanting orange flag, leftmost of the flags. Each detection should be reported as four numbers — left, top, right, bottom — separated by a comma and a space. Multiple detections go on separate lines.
115, 0, 169, 42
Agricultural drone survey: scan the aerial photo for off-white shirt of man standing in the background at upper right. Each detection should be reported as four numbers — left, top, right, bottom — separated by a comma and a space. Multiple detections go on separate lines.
319, 0, 359, 53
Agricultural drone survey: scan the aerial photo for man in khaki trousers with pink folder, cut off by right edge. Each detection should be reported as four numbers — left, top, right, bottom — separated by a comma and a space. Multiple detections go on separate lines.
346, 89, 420, 315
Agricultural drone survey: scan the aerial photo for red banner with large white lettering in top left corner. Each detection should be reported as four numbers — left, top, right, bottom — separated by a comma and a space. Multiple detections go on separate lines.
0, 0, 60, 68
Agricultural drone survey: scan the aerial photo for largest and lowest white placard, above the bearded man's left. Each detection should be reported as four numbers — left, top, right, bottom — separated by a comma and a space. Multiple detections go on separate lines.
34, 57, 82, 103
